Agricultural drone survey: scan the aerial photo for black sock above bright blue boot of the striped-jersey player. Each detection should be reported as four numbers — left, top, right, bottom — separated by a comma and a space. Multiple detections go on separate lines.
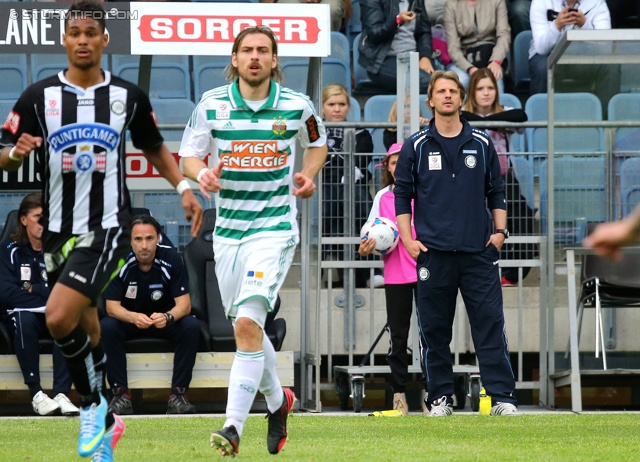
56, 326, 100, 407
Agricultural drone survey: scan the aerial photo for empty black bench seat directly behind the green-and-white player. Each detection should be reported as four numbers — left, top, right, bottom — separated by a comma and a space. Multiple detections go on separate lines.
183, 209, 287, 352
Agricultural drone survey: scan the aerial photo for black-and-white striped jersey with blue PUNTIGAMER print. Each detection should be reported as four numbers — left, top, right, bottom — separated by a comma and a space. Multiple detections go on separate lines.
0, 71, 163, 235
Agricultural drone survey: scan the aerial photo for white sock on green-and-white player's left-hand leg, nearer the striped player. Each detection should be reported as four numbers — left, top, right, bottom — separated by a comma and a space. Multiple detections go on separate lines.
224, 350, 264, 435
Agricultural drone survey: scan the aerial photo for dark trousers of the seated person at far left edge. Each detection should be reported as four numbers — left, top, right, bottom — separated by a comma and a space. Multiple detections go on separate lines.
13, 311, 71, 396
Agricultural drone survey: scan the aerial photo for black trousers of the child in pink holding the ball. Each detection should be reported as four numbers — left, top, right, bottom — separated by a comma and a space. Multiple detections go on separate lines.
384, 282, 416, 393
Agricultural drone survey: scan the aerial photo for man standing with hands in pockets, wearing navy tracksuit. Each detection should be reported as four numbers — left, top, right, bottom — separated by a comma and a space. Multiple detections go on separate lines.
394, 71, 516, 416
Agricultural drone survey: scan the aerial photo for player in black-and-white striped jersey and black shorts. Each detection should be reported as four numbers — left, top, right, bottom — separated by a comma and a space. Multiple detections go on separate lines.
0, 0, 202, 460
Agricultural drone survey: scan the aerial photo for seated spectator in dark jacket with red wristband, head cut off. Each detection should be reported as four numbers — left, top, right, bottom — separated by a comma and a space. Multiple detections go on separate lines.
358, 0, 433, 93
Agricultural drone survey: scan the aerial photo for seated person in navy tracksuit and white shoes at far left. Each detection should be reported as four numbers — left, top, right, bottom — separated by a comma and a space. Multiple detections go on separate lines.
0, 193, 79, 415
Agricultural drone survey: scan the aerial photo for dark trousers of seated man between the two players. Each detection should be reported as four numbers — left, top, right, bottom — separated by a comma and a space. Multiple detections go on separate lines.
100, 316, 200, 389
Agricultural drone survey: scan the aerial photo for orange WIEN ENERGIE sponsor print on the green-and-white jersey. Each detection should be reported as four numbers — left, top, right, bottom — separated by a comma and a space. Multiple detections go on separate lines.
220, 141, 288, 170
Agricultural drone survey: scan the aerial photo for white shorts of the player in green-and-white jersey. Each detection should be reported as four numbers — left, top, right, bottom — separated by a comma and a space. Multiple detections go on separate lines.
213, 236, 298, 324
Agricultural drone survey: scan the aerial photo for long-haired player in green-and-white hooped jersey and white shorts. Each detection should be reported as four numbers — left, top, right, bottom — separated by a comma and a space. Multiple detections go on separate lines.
180, 27, 327, 456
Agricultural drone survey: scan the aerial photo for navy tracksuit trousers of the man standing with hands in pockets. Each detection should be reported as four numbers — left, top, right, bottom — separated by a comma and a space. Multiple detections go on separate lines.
417, 244, 517, 404
